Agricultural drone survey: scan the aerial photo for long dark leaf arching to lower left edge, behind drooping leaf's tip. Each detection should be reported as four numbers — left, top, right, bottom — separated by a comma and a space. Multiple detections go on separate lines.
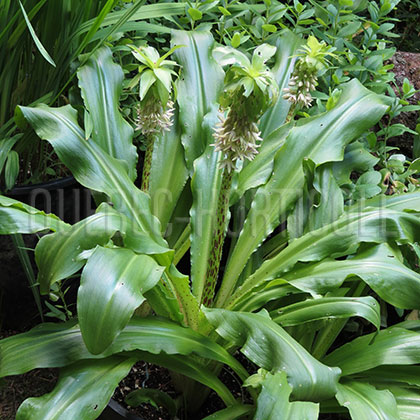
0, 317, 248, 380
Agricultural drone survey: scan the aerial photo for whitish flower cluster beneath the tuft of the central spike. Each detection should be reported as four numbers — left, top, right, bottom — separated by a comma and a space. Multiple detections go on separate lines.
212, 111, 262, 172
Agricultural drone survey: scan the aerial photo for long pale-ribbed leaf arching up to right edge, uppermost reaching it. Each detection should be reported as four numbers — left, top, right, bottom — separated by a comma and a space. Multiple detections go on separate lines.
231, 208, 420, 302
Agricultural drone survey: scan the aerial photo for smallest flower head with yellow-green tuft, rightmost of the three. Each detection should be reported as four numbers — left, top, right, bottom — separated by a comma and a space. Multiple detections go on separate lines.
283, 35, 334, 107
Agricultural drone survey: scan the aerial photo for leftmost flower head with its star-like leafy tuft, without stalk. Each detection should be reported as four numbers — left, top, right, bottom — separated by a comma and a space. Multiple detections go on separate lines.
131, 46, 180, 137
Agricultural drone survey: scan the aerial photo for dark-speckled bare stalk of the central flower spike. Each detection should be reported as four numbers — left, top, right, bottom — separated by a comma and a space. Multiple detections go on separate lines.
202, 167, 233, 306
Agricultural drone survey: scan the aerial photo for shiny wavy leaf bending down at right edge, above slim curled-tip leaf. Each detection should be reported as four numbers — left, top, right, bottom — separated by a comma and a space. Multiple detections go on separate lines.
282, 244, 420, 309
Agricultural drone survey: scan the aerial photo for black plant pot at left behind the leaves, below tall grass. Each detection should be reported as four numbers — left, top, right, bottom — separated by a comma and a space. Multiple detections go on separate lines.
6, 176, 95, 224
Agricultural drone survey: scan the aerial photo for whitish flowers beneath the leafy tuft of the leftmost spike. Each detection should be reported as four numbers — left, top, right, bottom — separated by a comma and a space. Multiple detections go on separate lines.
135, 98, 174, 136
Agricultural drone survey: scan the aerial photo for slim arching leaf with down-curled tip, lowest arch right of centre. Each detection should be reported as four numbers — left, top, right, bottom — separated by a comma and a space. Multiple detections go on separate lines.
270, 296, 381, 330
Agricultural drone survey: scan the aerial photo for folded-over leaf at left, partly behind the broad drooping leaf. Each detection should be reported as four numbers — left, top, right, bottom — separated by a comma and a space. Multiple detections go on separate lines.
35, 203, 168, 293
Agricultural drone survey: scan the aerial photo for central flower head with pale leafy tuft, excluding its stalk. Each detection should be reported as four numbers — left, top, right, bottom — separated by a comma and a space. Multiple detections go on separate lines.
213, 44, 278, 172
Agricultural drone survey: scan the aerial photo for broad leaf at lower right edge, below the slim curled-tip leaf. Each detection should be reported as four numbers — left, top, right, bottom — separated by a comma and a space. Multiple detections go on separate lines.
323, 327, 420, 375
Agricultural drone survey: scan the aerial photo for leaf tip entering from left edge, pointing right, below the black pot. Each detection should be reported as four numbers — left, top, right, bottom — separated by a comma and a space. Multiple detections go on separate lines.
0, 195, 69, 235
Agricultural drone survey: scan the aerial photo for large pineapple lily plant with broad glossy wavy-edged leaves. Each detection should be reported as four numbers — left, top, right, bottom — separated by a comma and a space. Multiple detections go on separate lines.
0, 31, 420, 420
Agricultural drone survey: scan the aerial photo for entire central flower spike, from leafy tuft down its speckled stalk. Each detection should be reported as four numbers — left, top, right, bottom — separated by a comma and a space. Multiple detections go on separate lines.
202, 44, 278, 306
